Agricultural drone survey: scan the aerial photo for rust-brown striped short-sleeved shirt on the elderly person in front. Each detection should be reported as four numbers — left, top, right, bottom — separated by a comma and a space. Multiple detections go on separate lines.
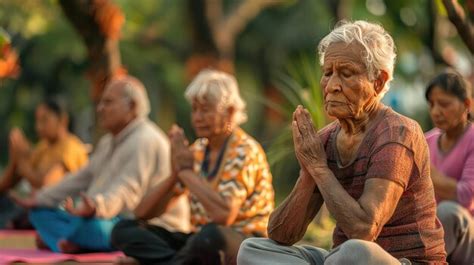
319, 108, 446, 264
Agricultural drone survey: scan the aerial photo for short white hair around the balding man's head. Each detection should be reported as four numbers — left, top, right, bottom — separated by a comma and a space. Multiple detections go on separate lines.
109, 76, 150, 117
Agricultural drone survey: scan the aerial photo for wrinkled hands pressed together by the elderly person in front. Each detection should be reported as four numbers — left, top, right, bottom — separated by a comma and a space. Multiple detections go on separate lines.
292, 106, 327, 176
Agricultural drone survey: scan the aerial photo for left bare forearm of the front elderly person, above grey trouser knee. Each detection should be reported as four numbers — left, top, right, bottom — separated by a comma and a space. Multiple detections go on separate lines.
268, 170, 324, 245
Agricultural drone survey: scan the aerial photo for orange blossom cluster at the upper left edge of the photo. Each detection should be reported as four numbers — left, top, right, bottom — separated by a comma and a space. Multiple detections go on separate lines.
0, 28, 20, 79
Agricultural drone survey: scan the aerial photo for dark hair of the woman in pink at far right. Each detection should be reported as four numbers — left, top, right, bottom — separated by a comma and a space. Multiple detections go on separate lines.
425, 69, 472, 120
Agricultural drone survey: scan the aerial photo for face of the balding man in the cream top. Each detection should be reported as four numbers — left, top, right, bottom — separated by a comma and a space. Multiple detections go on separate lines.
97, 82, 134, 134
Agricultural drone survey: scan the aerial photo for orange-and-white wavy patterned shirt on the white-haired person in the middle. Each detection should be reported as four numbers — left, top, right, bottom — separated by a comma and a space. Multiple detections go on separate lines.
190, 129, 274, 236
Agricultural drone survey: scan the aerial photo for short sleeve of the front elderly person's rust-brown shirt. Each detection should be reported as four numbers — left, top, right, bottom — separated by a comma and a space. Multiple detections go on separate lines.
367, 142, 414, 190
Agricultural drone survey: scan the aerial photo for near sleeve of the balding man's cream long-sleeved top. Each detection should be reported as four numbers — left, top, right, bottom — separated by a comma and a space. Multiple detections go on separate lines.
92, 137, 169, 218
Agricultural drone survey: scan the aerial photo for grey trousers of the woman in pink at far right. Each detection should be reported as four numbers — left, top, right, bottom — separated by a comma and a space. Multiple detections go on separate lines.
437, 201, 474, 265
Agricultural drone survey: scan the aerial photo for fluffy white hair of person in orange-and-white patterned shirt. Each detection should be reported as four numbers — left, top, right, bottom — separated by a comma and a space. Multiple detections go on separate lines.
184, 69, 247, 125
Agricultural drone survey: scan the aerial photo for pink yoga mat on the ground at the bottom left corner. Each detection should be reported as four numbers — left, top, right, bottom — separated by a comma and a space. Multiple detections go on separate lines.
0, 249, 123, 265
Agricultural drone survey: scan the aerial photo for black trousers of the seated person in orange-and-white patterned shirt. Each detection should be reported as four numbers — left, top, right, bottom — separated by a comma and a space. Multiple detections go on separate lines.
112, 220, 247, 265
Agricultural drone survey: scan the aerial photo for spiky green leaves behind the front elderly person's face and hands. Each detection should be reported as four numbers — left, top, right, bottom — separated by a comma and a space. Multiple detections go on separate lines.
250, 55, 327, 201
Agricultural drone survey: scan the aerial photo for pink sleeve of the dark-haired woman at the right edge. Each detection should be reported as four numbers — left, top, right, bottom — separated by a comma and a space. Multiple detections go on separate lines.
457, 146, 474, 210
